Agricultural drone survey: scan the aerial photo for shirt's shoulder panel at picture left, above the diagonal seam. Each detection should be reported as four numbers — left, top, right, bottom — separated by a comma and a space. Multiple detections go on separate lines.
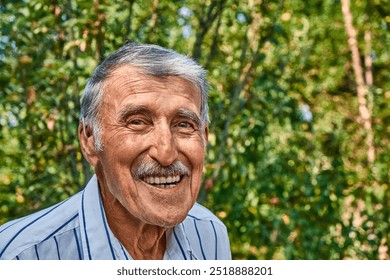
0, 193, 81, 259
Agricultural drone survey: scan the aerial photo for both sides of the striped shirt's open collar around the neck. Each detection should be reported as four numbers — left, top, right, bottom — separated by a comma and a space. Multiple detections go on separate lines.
79, 175, 197, 260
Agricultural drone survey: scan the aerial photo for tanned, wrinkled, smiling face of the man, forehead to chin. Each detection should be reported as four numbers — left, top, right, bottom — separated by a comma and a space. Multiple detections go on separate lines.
90, 66, 207, 227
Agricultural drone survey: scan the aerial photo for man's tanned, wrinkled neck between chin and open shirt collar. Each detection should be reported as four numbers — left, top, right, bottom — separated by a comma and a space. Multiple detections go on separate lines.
100, 180, 166, 260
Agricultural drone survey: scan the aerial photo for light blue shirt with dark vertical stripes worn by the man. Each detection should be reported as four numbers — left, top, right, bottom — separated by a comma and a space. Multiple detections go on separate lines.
0, 176, 231, 260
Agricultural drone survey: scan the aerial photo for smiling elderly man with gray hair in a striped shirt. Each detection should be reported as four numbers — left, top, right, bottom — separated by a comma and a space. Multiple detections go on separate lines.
0, 44, 231, 260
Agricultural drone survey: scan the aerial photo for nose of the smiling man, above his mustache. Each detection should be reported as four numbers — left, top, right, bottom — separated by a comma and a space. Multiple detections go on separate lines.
149, 125, 178, 166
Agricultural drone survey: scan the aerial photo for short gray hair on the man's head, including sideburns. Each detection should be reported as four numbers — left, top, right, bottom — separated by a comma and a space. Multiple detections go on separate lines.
80, 43, 209, 150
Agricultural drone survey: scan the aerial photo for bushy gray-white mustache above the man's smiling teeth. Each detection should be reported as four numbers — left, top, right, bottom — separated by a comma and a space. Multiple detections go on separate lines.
132, 161, 191, 179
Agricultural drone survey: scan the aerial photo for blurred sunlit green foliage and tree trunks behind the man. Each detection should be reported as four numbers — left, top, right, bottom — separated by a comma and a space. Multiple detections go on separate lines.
0, 0, 390, 259
